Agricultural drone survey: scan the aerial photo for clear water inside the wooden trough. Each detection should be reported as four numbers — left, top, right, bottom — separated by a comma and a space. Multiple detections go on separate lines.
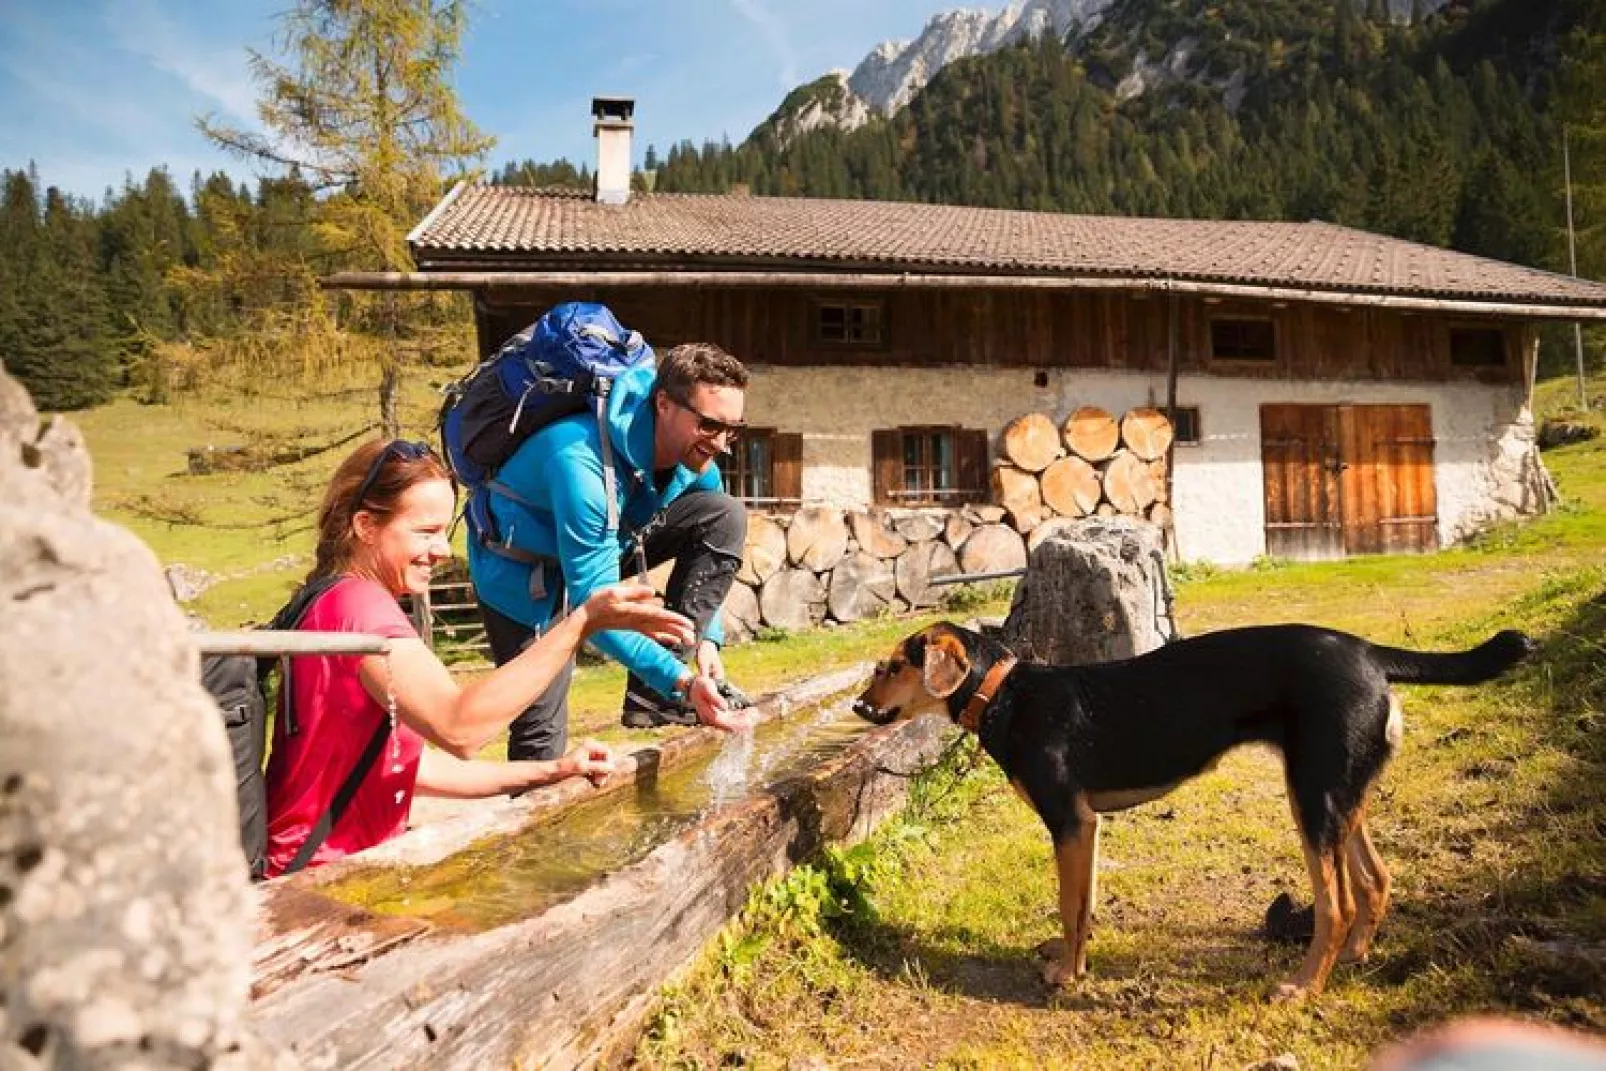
323, 697, 870, 930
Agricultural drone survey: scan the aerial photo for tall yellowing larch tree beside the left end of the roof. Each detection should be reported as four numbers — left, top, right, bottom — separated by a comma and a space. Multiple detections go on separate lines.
199, 0, 493, 437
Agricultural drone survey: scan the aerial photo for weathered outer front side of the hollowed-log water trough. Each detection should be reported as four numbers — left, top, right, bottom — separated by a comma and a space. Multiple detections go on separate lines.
252, 706, 941, 1068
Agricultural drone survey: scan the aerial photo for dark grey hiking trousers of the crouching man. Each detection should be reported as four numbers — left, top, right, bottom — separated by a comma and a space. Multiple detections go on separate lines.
480, 491, 747, 759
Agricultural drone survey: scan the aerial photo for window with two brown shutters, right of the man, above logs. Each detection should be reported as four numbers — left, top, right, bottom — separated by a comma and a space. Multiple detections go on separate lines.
870, 426, 988, 506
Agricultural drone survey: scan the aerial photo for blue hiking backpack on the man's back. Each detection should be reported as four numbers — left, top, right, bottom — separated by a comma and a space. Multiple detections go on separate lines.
440, 302, 654, 551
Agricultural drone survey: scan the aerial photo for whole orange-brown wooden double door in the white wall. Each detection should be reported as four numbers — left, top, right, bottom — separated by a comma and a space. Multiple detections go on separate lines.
1261, 405, 1439, 560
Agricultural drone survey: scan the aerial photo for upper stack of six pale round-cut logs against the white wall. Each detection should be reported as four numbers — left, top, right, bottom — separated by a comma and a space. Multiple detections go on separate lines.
993, 406, 1171, 533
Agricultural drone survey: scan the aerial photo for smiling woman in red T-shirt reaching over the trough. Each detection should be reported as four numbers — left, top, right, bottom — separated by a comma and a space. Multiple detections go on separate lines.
267, 440, 694, 877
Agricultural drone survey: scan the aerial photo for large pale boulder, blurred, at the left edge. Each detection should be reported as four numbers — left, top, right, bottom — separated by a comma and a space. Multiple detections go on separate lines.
0, 368, 283, 1068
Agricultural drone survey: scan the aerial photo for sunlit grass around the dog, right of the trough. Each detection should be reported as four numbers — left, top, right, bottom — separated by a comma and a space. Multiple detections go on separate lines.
636, 385, 1606, 1068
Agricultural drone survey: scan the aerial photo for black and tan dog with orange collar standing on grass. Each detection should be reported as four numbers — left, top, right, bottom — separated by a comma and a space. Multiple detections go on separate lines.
854, 623, 1534, 999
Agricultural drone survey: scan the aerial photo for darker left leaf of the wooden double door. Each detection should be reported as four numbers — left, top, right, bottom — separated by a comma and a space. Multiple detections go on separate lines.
1261, 405, 1344, 560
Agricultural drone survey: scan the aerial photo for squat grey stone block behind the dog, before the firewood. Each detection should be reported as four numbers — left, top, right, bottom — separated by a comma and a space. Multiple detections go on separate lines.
1004, 517, 1176, 665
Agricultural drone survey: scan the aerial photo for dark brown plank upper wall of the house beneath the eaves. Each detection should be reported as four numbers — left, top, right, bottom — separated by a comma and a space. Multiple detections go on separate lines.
475, 287, 1524, 384
